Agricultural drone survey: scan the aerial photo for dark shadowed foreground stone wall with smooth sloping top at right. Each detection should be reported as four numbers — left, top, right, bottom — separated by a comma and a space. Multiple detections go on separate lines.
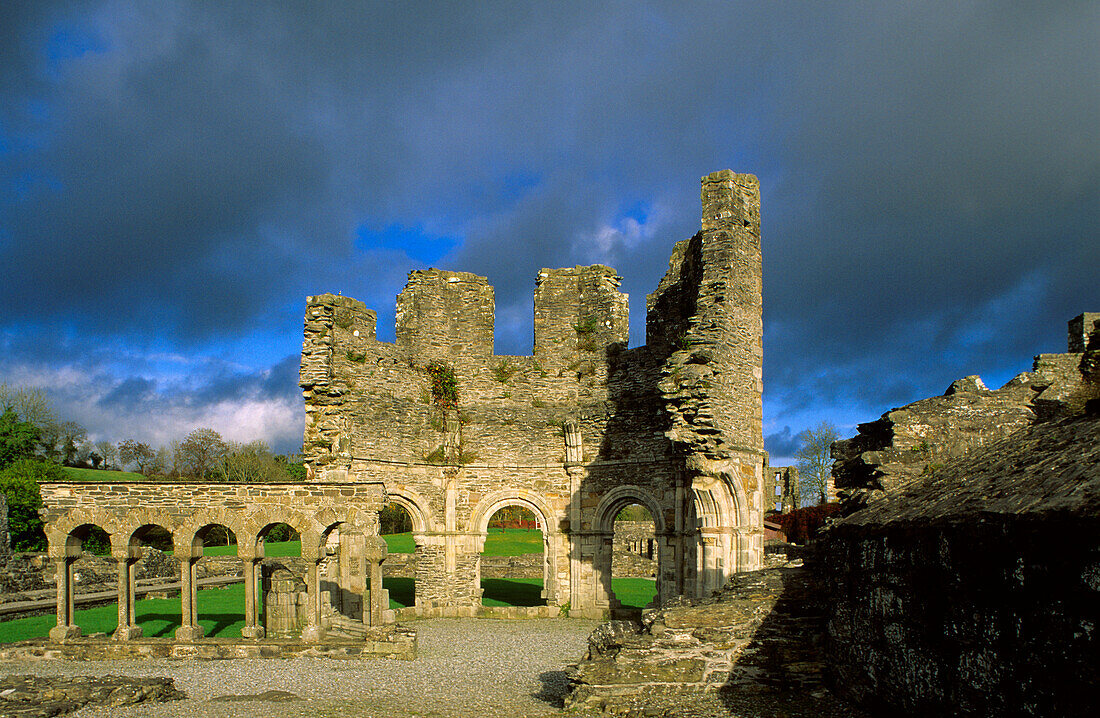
820, 417, 1100, 716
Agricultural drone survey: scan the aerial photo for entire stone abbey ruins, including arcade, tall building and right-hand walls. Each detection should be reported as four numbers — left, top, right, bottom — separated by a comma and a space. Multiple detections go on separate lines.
10, 170, 1100, 716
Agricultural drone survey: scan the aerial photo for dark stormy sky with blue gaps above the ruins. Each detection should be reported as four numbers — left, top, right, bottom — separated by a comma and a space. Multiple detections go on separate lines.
0, 2, 1100, 448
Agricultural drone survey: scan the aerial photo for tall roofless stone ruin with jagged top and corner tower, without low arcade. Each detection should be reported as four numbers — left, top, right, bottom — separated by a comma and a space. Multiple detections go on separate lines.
300, 170, 765, 616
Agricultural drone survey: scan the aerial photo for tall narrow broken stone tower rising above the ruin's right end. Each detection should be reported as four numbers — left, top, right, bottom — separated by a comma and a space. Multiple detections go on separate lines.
647, 170, 763, 459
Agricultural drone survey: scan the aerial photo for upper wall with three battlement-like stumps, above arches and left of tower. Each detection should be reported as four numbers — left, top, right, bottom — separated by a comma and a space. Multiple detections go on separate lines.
300, 266, 668, 467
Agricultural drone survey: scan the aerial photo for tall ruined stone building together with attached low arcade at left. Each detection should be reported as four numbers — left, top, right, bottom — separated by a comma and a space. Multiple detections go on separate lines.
30, 170, 766, 652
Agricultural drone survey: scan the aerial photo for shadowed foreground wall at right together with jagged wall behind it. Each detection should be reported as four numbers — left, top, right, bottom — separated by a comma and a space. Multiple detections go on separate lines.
813, 314, 1100, 716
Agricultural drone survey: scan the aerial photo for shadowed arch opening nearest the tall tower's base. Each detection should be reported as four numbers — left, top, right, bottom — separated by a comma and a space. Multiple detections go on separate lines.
611, 504, 659, 609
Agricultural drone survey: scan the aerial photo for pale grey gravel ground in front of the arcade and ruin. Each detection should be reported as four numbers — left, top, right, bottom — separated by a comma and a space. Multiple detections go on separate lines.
0, 619, 597, 718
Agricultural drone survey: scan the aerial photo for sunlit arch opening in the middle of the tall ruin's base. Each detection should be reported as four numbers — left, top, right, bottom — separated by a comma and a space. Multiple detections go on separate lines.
481, 501, 550, 606
